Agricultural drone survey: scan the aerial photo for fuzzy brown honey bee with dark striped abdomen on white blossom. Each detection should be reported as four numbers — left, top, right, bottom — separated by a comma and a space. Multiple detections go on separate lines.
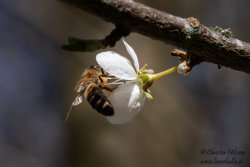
65, 65, 114, 122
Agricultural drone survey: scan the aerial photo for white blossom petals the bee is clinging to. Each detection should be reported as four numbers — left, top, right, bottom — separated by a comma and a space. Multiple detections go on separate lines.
96, 40, 145, 124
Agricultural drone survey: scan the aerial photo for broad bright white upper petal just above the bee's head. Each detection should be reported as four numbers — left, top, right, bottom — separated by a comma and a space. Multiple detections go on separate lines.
96, 51, 136, 80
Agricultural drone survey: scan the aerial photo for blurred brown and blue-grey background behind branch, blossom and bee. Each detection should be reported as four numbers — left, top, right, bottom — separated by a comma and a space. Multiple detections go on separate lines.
0, 0, 250, 167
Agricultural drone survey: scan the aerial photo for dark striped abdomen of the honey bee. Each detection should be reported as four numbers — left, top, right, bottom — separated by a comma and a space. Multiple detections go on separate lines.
84, 84, 114, 116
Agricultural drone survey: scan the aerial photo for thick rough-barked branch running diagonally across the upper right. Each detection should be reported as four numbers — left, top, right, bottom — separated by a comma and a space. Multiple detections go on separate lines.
63, 0, 250, 74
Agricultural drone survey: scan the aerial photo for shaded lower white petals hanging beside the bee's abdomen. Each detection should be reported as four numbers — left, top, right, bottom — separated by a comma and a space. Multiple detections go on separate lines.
107, 83, 145, 124
